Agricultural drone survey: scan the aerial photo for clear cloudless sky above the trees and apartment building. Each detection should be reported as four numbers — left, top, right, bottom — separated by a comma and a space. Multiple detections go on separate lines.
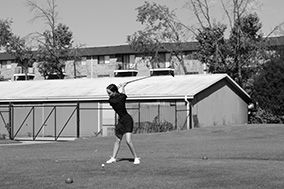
0, 0, 284, 47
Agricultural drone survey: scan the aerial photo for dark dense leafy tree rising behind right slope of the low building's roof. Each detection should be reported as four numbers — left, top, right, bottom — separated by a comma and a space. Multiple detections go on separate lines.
229, 14, 266, 86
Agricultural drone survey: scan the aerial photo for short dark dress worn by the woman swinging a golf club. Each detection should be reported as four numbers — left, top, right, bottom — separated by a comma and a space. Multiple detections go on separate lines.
109, 93, 133, 139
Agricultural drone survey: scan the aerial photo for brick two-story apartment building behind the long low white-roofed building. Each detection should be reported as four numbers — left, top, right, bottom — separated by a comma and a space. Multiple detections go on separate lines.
0, 42, 202, 80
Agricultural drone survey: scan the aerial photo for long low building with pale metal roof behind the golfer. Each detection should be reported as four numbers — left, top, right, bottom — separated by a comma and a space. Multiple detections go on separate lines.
0, 74, 250, 140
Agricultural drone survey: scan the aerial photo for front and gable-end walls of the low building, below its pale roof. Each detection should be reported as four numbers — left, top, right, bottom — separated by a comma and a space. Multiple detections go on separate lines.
0, 80, 248, 138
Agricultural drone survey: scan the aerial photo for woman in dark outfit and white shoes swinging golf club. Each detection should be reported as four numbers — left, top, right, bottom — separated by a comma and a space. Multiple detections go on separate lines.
106, 82, 140, 164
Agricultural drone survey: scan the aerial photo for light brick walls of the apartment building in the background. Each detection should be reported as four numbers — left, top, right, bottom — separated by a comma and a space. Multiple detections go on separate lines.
0, 53, 204, 80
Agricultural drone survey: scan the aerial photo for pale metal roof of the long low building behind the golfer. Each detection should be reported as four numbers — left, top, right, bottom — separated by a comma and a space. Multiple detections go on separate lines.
0, 74, 249, 102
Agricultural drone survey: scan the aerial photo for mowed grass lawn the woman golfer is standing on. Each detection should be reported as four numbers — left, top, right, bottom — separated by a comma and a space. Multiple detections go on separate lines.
0, 125, 284, 189
